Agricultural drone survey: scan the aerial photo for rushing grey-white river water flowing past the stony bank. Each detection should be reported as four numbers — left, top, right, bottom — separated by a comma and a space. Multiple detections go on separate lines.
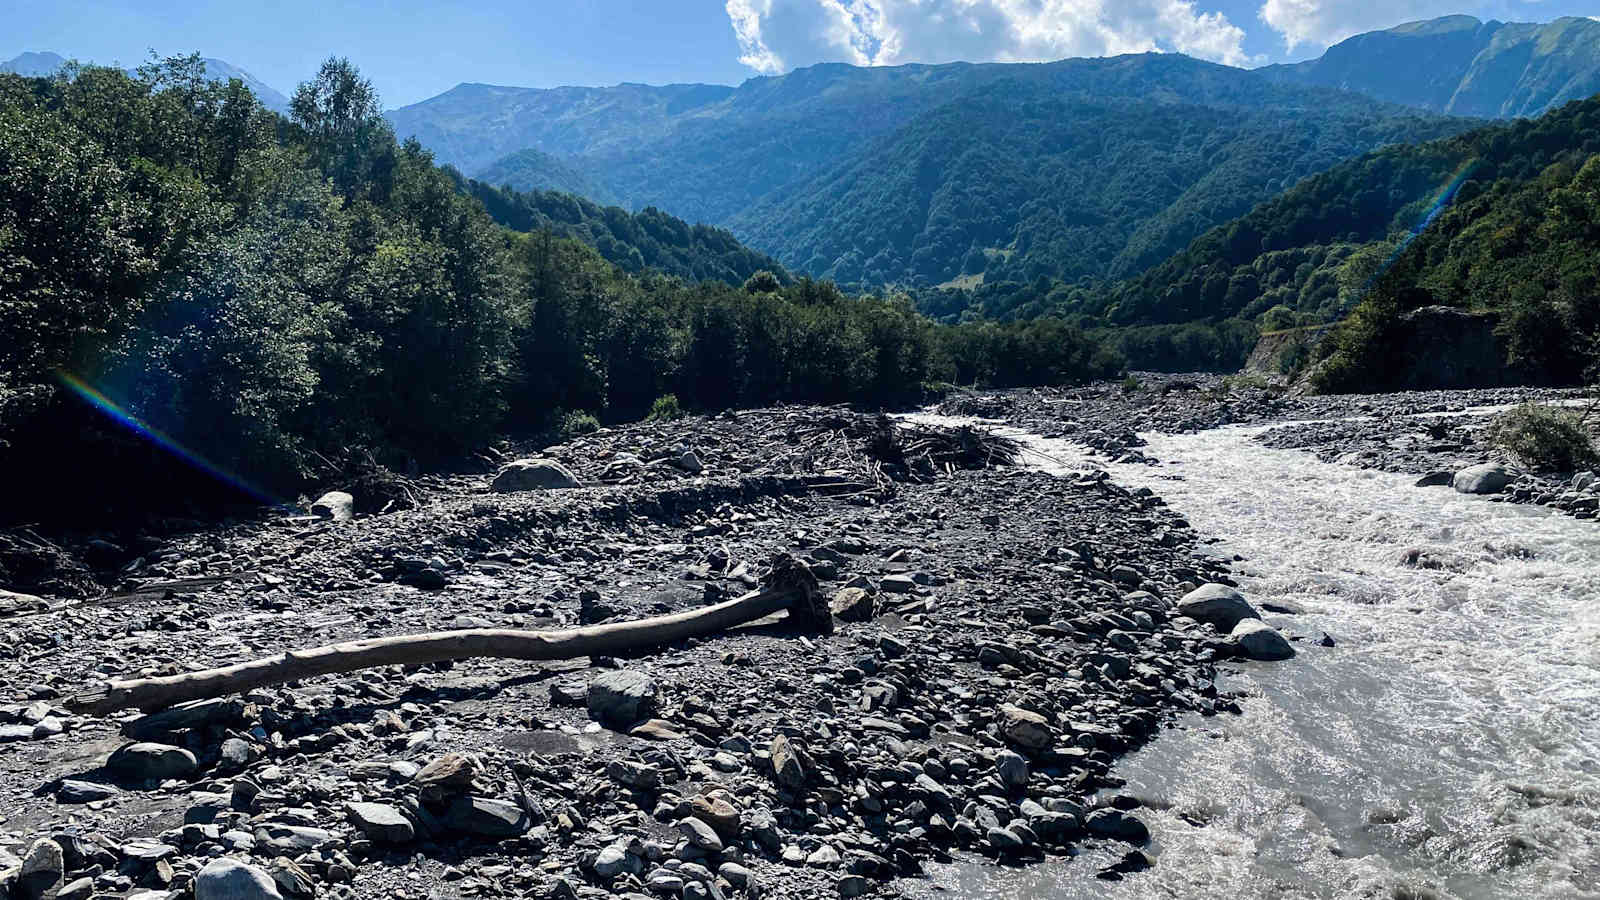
912, 416, 1600, 900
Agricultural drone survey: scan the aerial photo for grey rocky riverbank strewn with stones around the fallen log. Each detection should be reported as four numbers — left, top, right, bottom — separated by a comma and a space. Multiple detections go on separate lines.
0, 400, 1288, 900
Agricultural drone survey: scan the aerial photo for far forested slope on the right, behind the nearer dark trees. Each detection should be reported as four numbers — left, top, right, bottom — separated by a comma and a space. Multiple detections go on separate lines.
1061, 96, 1600, 325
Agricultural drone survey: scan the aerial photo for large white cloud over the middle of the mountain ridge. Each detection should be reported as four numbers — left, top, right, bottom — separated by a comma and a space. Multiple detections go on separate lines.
725, 0, 1254, 74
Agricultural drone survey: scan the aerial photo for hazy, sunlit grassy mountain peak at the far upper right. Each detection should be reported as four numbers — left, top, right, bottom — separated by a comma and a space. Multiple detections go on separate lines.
1258, 16, 1600, 119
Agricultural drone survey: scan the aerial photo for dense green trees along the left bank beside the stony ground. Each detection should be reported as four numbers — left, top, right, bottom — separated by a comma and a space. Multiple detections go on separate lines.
0, 56, 1120, 516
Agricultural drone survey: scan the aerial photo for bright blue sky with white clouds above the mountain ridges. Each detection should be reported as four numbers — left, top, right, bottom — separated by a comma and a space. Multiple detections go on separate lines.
0, 0, 1600, 106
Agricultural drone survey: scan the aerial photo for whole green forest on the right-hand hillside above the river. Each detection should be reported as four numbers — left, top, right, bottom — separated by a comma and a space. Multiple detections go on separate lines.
917, 90, 1600, 371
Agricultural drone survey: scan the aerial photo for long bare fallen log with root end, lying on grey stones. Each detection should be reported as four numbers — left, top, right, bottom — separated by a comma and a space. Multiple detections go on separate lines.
67, 556, 834, 716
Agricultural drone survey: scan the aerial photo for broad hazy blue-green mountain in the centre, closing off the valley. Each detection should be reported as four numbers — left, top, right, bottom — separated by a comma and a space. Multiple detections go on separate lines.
389, 54, 1467, 285
